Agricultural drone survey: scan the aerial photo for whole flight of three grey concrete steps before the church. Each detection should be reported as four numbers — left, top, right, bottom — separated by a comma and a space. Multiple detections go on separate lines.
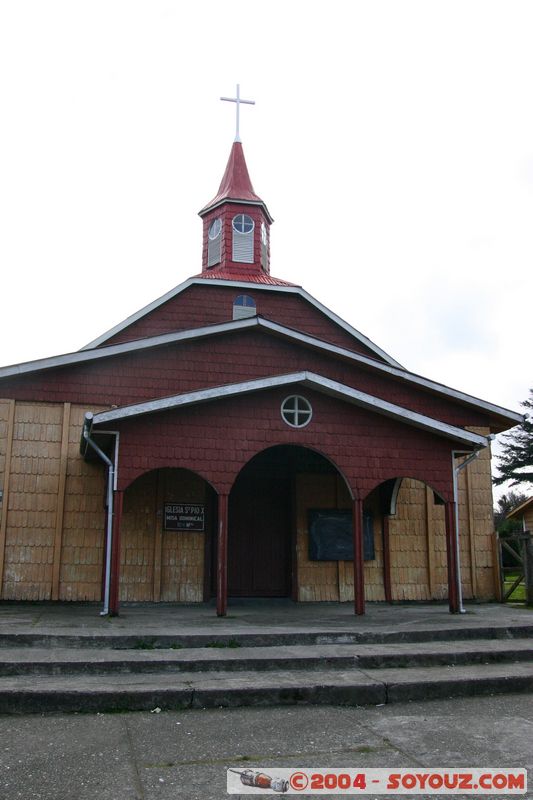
0, 616, 533, 714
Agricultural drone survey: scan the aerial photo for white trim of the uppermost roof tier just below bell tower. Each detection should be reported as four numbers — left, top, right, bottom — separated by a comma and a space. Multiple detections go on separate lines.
81, 278, 401, 368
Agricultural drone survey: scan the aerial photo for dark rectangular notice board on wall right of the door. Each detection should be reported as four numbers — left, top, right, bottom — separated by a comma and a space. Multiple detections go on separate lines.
308, 508, 376, 561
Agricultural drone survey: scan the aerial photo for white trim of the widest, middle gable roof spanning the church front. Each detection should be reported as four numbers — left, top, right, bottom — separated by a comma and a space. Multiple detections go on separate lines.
0, 317, 524, 424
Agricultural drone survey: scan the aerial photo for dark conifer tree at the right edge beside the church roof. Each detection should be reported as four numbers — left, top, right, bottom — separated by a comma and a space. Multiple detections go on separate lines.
493, 389, 533, 488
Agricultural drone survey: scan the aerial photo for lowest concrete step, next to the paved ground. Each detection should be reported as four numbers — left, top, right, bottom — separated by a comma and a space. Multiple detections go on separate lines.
0, 663, 533, 714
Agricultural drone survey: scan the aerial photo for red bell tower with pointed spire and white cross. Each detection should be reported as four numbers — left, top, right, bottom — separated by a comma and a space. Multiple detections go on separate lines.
199, 86, 273, 281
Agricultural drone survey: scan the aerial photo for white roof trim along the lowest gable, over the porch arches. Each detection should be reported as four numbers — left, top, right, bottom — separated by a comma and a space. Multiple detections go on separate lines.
94, 371, 489, 447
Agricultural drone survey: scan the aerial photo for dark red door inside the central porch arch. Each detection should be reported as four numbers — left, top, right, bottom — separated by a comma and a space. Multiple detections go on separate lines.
228, 465, 291, 597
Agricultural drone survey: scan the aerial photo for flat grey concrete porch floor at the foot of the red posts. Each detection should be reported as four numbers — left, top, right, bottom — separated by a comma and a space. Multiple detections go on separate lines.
0, 599, 533, 637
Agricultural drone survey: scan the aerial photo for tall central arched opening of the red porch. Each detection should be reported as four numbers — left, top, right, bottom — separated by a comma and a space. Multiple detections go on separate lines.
222, 445, 353, 601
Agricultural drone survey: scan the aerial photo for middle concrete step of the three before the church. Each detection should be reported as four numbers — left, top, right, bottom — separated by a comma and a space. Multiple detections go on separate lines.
0, 639, 533, 676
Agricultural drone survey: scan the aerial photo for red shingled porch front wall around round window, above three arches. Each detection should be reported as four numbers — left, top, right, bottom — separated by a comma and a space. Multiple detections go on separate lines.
117, 388, 458, 497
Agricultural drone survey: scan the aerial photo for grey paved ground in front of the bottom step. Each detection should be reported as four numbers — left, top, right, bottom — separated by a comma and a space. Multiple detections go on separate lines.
0, 695, 533, 800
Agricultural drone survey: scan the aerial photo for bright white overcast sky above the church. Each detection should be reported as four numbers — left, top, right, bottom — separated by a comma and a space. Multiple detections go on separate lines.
0, 0, 533, 496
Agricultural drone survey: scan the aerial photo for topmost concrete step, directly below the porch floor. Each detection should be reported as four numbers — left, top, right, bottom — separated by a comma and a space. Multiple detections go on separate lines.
0, 620, 533, 654
